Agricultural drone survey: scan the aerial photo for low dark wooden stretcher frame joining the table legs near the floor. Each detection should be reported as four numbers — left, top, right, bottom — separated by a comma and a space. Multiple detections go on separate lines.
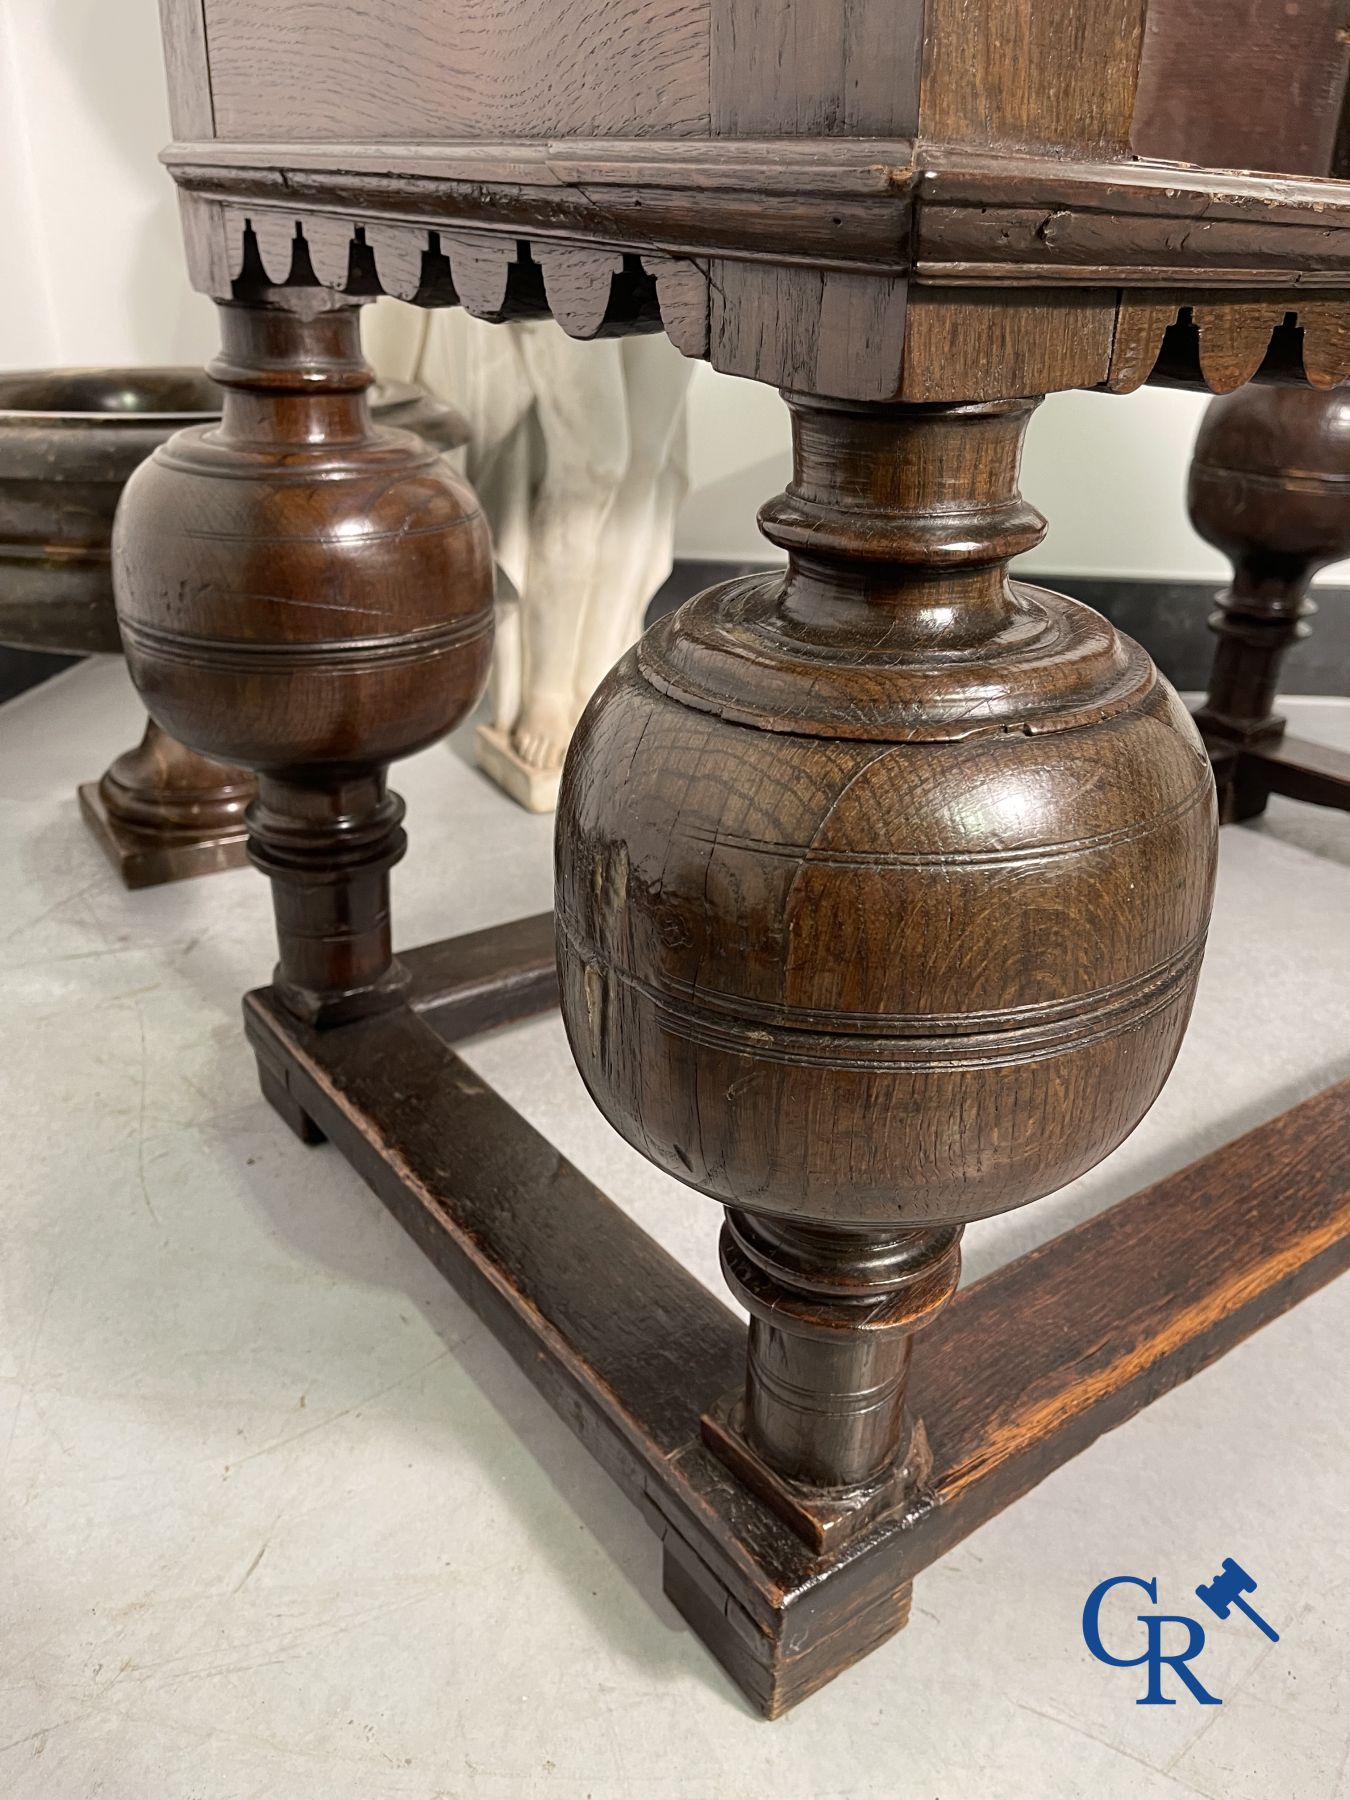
245, 913, 1350, 1717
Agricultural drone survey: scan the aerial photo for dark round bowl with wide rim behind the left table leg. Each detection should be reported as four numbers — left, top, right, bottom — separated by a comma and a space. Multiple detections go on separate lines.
0, 369, 468, 655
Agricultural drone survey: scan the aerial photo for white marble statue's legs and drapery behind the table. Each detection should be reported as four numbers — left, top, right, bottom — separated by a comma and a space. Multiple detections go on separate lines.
365, 301, 693, 812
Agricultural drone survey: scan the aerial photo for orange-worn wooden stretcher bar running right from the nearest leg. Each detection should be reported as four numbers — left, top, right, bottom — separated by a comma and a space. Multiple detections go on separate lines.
913, 1082, 1350, 1559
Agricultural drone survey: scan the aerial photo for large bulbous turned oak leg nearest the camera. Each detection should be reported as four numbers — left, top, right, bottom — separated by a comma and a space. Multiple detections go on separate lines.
558, 396, 1215, 1548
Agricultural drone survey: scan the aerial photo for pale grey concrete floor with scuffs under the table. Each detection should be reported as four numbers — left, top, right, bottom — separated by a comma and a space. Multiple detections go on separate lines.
0, 664, 1350, 1800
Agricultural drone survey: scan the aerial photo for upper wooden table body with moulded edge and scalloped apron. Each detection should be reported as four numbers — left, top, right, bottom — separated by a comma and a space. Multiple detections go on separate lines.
164, 0, 1350, 400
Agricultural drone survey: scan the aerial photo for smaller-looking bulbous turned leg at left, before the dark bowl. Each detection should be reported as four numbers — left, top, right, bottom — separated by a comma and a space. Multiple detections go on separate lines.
113, 292, 491, 1024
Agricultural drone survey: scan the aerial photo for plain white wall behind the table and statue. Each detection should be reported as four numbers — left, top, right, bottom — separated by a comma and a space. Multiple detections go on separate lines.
0, 0, 1350, 580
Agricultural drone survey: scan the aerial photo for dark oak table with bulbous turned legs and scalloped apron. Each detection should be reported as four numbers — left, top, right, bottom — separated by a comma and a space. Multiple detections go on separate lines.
113, 0, 1350, 1715
